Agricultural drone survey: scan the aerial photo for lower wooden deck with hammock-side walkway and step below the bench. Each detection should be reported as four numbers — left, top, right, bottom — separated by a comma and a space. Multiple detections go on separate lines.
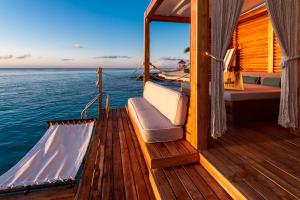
76, 110, 229, 199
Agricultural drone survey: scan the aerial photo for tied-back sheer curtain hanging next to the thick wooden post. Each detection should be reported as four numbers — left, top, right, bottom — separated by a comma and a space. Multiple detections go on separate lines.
211, 0, 244, 138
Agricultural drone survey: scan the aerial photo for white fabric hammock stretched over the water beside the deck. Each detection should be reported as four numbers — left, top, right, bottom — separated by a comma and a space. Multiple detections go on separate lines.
0, 122, 94, 190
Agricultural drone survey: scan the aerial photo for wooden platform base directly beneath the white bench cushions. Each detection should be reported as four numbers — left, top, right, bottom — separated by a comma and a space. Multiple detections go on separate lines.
126, 106, 199, 169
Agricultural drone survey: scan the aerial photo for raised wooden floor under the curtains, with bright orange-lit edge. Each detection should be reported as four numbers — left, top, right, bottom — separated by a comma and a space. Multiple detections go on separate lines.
200, 123, 300, 199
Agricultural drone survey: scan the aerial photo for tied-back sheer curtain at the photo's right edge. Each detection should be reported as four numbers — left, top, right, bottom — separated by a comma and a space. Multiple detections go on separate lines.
266, 0, 300, 128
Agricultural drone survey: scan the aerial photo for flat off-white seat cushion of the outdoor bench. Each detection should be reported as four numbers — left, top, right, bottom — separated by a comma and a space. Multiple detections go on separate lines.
128, 98, 183, 143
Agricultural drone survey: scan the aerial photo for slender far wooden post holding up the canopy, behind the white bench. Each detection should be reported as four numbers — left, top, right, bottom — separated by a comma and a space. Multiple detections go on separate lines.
144, 17, 150, 84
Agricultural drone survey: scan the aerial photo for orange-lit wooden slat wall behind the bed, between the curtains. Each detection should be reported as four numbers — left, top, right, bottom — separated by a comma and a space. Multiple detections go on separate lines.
232, 8, 281, 73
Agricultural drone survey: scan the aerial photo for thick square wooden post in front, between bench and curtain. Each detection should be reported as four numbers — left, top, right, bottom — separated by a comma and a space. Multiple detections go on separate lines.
190, 0, 210, 150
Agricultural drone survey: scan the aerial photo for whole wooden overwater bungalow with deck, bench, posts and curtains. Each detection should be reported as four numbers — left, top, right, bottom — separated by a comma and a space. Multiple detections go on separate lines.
0, 0, 300, 200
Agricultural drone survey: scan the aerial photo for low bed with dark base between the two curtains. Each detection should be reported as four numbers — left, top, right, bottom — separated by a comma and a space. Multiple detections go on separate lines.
182, 81, 280, 123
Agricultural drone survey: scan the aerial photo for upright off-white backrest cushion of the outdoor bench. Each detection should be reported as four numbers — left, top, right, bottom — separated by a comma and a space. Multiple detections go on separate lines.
144, 81, 188, 125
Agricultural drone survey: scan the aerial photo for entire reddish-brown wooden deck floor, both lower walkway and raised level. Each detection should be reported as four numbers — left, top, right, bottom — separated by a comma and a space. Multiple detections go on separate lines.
0, 110, 300, 200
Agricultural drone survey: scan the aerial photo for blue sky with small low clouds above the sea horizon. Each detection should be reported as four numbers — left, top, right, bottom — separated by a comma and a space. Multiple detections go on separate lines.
0, 0, 189, 67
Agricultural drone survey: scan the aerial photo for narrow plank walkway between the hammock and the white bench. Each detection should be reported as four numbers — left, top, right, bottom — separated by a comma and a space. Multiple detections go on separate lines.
77, 109, 154, 200
